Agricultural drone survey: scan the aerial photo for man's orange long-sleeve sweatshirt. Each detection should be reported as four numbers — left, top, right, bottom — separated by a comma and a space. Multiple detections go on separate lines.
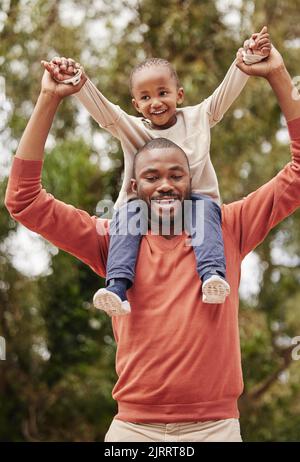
6, 118, 300, 423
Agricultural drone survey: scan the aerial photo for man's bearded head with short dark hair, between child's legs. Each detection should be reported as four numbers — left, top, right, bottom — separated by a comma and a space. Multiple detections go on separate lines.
131, 148, 191, 226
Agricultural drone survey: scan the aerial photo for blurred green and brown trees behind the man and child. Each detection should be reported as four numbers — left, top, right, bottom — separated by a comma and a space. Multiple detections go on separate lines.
0, 0, 300, 441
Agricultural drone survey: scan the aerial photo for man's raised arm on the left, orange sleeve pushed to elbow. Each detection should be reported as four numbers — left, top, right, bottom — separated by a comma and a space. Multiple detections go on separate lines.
5, 71, 108, 276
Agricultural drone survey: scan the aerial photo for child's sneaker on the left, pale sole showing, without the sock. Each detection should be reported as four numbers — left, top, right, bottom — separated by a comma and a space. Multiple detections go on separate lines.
93, 289, 131, 316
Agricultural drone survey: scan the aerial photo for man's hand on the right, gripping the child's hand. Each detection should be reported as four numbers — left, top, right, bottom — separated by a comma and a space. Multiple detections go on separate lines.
236, 45, 285, 79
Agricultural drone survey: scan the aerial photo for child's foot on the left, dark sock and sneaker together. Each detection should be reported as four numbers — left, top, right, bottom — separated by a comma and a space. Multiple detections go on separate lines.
93, 278, 131, 316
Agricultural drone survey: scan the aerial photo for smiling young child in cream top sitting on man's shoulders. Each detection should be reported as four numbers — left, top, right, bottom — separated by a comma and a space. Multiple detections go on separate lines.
42, 27, 271, 315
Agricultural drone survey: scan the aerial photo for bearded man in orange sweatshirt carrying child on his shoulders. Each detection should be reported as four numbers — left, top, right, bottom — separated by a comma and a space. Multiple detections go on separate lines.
6, 48, 300, 442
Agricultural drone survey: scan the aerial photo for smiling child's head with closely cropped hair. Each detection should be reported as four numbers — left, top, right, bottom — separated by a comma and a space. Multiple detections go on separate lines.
132, 66, 184, 129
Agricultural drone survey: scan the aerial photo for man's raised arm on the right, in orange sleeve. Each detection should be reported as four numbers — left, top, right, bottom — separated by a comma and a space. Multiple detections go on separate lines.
223, 47, 300, 257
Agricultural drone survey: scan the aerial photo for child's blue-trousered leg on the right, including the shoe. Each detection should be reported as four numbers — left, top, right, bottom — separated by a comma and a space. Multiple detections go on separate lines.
185, 193, 230, 303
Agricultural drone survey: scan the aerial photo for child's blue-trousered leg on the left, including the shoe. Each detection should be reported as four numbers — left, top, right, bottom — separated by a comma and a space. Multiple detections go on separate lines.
93, 199, 148, 316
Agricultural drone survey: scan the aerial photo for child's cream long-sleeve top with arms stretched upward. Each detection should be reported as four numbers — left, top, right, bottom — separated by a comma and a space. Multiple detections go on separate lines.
75, 61, 248, 208
